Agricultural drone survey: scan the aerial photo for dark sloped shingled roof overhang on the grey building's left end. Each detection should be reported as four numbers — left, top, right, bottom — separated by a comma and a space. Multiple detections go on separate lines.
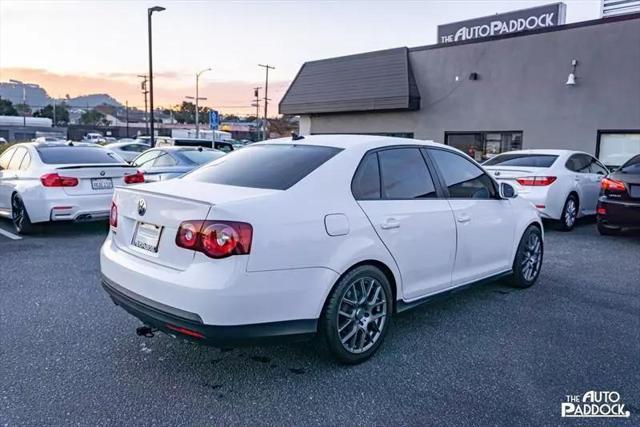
280, 47, 420, 114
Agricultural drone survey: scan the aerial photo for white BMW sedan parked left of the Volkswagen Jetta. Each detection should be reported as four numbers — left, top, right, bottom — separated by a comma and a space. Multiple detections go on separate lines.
0, 142, 144, 234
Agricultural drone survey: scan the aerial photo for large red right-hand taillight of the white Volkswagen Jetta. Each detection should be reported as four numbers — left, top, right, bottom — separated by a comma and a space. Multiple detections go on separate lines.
176, 220, 253, 258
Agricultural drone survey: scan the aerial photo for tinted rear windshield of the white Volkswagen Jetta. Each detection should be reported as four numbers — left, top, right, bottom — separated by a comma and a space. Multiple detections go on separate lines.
185, 144, 341, 190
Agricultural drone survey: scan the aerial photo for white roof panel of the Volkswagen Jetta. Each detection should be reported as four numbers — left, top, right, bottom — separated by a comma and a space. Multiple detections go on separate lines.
251, 135, 444, 150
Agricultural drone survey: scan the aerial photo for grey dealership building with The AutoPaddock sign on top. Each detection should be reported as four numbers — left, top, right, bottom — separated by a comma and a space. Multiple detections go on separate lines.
280, 3, 640, 166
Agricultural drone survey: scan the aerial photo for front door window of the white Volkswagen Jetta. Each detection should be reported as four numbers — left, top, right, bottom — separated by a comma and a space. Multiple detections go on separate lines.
428, 149, 496, 199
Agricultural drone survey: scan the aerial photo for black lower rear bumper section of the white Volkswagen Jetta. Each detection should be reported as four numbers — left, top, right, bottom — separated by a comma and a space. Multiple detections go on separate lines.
102, 275, 317, 346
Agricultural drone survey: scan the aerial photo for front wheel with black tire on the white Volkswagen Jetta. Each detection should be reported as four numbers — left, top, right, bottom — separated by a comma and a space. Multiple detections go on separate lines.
509, 225, 544, 288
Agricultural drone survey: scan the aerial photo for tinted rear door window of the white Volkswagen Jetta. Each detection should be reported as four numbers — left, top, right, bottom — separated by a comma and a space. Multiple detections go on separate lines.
378, 148, 437, 200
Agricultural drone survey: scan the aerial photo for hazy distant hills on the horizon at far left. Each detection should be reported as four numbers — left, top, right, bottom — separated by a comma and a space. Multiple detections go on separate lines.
0, 80, 124, 110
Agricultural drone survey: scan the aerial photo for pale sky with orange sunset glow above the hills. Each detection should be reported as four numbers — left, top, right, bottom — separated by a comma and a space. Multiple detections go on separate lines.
0, 0, 600, 114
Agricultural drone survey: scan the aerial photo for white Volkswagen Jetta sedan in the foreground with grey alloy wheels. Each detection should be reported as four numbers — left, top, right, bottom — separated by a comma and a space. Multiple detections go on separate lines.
100, 135, 543, 363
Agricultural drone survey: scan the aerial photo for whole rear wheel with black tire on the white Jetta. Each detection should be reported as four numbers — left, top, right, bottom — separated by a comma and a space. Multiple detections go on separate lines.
319, 265, 393, 365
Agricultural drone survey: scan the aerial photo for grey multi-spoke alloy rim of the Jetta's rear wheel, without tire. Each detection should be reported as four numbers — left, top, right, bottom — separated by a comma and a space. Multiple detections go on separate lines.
336, 277, 387, 354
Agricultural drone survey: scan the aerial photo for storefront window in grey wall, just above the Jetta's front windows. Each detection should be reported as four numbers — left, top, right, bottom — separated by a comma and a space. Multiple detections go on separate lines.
445, 132, 522, 162
